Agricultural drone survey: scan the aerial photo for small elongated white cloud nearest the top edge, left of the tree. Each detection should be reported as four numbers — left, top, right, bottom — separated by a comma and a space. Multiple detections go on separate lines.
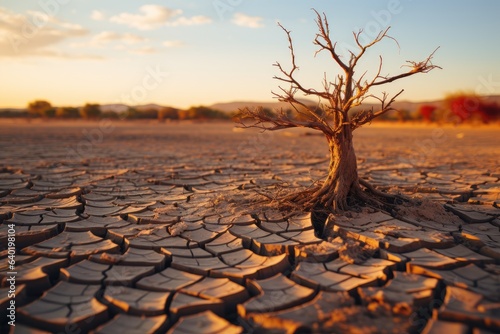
109, 5, 212, 30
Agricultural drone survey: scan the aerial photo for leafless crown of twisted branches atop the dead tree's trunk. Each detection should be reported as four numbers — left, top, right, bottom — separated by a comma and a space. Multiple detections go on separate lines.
241, 9, 440, 136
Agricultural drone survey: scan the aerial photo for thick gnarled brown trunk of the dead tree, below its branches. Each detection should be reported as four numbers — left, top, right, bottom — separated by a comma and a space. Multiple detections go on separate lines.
312, 125, 360, 211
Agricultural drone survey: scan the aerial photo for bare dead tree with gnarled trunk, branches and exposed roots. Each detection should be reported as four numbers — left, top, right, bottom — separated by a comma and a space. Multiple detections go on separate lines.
239, 11, 439, 212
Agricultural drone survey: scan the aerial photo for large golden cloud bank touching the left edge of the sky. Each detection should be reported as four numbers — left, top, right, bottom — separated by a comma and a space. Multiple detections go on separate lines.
0, 7, 93, 58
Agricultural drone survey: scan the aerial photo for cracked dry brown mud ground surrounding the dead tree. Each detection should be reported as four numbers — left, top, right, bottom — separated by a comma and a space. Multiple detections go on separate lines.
0, 121, 500, 333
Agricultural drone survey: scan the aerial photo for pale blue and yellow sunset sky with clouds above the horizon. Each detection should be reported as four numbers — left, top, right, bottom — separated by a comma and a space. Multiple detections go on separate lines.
0, 0, 500, 108
